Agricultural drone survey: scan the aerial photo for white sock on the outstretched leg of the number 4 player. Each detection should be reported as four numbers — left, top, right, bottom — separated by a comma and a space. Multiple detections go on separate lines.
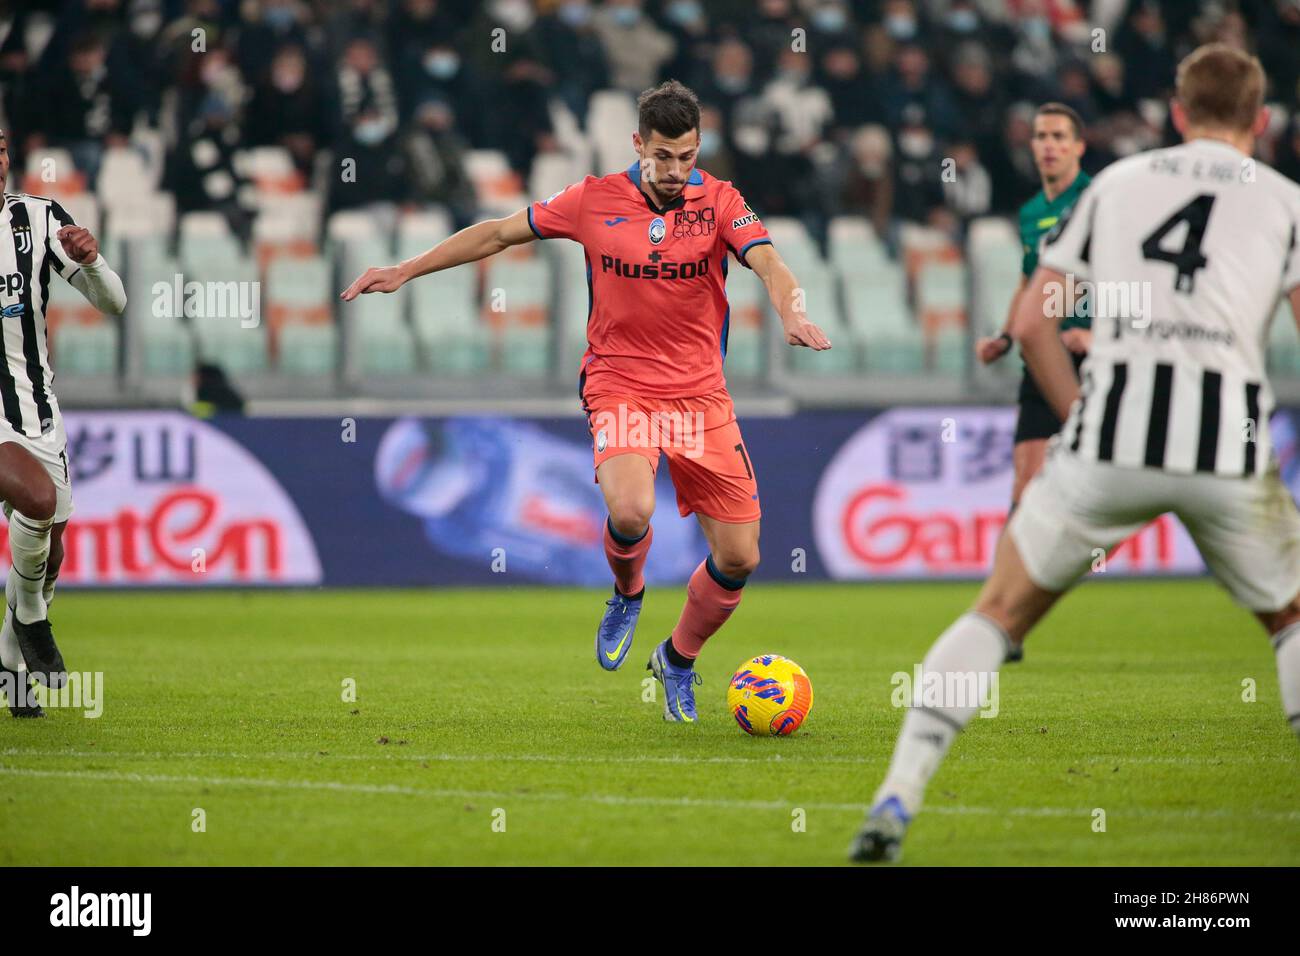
872, 611, 1011, 816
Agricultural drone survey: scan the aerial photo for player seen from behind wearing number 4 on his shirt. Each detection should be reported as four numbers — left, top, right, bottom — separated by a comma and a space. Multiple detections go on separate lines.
850, 44, 1300, 862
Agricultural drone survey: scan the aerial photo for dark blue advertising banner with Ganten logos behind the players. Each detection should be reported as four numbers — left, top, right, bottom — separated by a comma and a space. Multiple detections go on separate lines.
0, 407, 1300, 587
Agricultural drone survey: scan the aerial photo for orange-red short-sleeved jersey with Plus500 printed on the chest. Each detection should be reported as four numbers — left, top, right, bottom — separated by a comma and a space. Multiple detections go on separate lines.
528, 164, 772, 398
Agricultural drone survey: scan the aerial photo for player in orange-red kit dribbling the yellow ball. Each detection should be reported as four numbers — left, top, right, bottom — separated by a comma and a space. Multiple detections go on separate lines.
342, 81, 831, 722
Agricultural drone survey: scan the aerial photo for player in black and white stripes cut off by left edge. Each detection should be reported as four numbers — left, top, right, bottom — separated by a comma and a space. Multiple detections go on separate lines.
0, 130, 126, 717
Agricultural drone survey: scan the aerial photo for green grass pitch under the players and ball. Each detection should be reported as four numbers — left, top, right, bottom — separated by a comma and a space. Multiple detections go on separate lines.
0, 580, 1300, 866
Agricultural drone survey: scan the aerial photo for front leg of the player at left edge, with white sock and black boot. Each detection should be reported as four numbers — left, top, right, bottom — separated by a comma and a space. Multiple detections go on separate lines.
0, 442, 66, 688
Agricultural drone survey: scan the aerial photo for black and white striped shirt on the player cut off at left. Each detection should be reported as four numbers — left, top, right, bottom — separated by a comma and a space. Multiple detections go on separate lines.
0, 193, 94, 438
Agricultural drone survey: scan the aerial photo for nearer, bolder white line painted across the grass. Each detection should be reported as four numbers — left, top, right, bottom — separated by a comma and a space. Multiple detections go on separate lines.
0, 766, 1300, 822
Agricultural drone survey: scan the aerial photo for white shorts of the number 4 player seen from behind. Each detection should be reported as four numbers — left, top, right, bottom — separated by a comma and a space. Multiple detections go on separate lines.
1008, 444, 1300, 611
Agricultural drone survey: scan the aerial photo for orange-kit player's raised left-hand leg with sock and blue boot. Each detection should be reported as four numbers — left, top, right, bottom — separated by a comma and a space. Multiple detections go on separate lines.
595, 453, 654, 671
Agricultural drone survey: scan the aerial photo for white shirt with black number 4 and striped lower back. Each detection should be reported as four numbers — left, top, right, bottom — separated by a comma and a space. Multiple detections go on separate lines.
1040, 139, 1300, 476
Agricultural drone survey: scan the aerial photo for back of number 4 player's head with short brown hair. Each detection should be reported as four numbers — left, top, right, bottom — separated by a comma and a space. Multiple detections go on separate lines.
1177, 43, 1264, 130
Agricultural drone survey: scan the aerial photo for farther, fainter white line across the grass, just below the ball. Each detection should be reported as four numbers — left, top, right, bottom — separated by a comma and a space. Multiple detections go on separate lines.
0, 744, 1294, 767
